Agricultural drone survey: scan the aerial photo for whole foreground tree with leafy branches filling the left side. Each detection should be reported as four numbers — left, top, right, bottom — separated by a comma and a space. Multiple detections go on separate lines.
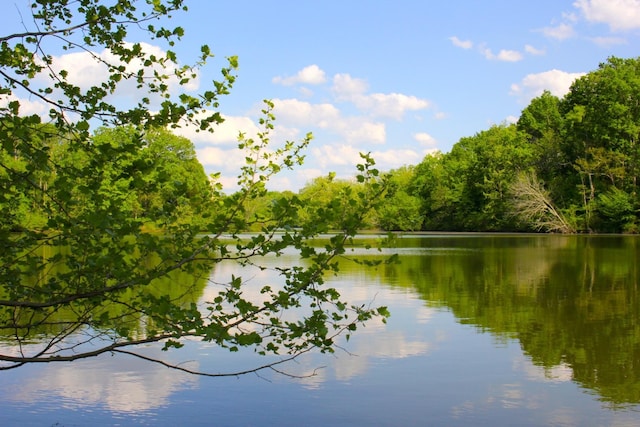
0, 0, 388, 375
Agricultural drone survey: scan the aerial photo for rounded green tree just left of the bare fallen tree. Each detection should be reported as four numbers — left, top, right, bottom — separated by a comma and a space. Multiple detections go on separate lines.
416, 125, 532, 231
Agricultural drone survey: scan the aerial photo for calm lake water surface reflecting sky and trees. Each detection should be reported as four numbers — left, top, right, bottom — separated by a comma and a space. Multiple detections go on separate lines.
0, 235, 640, 426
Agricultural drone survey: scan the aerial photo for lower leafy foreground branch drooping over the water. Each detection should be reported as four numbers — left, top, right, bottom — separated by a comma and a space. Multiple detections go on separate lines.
0, 109, 388, 376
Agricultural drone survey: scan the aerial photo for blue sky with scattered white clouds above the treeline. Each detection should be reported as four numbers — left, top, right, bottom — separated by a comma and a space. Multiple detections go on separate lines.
0, 0, 640, 191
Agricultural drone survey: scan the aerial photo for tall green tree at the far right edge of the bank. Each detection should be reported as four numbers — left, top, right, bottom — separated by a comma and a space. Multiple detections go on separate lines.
560, 57, 640, 230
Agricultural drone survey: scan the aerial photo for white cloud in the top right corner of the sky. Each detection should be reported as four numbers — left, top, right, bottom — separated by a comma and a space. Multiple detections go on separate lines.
573, 0, 640, 31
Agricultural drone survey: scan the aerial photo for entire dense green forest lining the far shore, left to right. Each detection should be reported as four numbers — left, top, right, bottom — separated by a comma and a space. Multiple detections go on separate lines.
6, 57, 640, 233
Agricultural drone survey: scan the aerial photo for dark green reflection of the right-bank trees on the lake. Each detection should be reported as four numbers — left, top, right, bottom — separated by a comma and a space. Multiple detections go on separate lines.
370, 236, 640, 405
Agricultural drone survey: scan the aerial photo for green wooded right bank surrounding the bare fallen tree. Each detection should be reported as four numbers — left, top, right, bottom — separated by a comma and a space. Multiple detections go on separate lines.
413, 58, 640, 233
